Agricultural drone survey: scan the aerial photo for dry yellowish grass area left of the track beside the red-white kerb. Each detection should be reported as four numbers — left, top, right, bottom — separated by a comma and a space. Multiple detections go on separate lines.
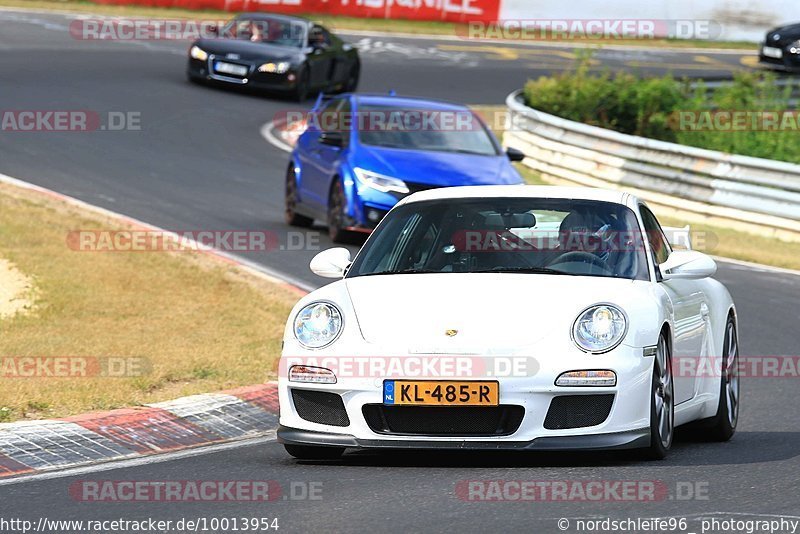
0, 185, 298, 422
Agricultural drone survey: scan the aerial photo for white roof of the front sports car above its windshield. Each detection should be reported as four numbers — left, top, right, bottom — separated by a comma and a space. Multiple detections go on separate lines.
400, 185, 637, 207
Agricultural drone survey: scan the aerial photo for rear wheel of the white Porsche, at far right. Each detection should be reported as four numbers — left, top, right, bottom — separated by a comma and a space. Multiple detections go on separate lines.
693, 317, 740, 441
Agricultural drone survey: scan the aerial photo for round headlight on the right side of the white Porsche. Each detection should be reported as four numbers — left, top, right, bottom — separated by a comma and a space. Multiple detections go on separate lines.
572, 304, 628, 353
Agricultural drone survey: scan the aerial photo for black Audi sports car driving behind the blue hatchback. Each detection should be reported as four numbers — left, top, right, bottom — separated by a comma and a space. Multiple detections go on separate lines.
187, 13, 361, 101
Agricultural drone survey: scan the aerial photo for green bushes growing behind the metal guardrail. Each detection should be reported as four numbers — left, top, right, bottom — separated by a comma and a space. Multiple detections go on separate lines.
524, 53, 800, 163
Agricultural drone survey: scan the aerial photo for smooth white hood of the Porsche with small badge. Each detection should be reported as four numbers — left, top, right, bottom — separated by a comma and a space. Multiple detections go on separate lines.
344, 273, 655, 354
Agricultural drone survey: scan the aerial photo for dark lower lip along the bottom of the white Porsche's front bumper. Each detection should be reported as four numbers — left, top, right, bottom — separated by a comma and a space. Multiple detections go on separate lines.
278, 426, 650, 451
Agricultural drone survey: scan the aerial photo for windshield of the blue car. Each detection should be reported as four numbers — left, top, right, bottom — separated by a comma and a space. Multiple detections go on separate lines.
357, 104, 499, 156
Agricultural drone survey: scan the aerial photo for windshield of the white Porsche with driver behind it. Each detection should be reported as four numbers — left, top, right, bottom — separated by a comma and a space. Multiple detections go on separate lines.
347, 198, 648, 280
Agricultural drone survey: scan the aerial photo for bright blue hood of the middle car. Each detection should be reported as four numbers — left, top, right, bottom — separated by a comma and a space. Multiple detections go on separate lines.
355, 145, 522, 186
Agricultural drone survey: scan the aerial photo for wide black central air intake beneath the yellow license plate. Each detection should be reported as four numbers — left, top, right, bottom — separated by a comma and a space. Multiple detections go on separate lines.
363, 404, 525, 436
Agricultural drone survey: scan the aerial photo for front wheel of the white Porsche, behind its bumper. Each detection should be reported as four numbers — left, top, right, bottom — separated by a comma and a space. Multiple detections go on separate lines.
642, 333, 675, 460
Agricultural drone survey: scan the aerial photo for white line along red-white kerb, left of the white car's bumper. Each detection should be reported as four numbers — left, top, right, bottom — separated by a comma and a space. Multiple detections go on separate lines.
0, 436, 276, 486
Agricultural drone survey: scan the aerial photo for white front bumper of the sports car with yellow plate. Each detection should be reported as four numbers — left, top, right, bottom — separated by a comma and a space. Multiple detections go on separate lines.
278, 346, 653, 450
